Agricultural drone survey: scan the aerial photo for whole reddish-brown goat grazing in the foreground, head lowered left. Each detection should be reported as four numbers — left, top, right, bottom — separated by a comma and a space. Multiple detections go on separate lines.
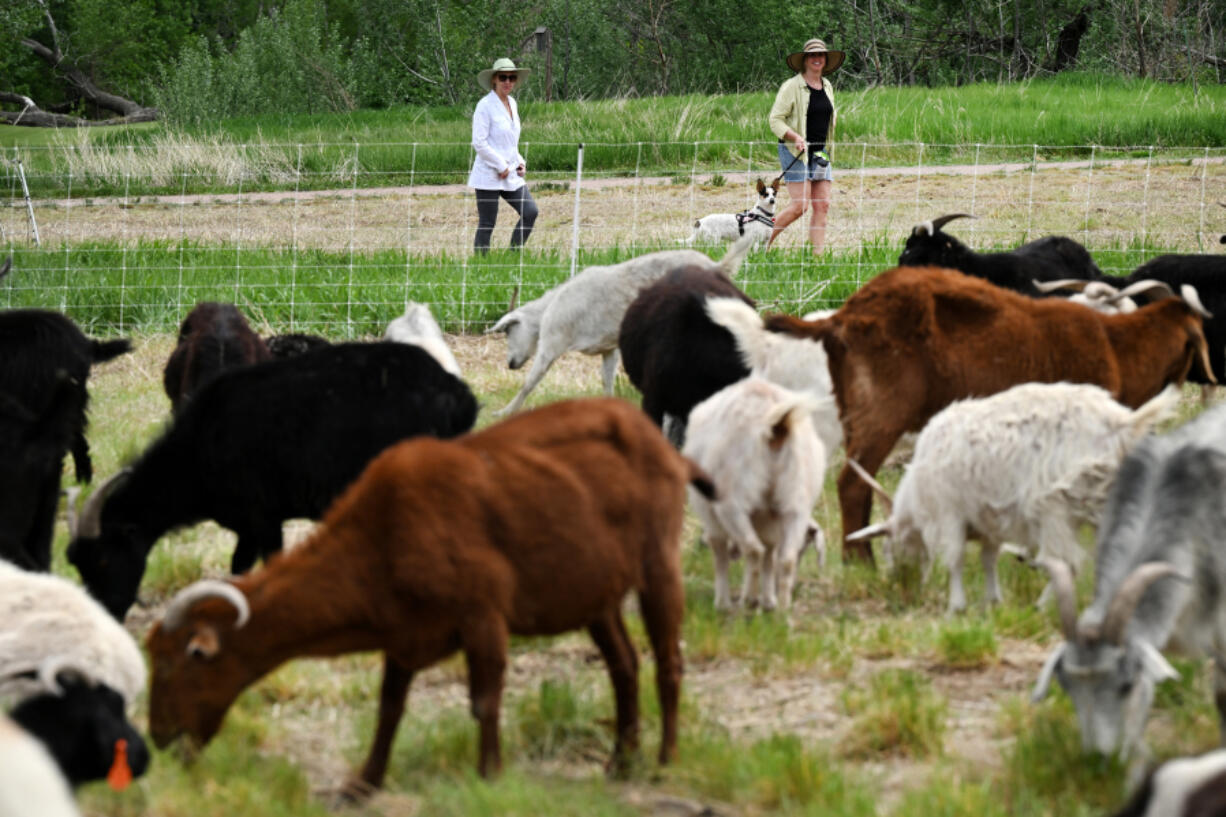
148, 399, 714, 797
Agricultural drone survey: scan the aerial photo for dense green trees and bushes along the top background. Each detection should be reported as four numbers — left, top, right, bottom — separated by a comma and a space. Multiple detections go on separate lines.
0, 0, 1226, 125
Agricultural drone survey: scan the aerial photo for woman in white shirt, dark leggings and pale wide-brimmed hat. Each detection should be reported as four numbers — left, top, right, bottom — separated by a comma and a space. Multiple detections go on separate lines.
468, 56, 538, 253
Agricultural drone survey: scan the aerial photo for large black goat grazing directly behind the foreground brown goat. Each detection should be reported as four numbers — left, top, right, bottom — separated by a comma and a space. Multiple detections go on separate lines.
69, 343, 477, 621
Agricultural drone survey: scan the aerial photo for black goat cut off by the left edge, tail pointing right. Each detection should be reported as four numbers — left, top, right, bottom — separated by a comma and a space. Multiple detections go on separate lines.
0, 309, 131, 570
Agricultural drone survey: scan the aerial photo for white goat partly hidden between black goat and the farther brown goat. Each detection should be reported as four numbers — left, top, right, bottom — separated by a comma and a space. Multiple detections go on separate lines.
706, 298, 842, 455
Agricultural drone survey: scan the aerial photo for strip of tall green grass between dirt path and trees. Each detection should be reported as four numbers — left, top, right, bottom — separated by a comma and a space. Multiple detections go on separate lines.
0, 74, 1226, 196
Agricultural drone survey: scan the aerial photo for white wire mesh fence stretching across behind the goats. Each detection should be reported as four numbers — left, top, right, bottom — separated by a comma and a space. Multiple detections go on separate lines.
0, 142, 1226, 336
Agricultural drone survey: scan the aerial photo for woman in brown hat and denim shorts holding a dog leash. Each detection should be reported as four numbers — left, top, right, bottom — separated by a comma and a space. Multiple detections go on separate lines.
766, 39, 846, 254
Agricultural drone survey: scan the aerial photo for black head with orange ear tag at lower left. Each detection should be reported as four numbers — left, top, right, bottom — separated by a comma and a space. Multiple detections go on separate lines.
9, 671, 150, 786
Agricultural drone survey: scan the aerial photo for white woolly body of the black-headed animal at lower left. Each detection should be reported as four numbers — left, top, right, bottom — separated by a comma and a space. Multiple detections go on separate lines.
0, 554, 145, 708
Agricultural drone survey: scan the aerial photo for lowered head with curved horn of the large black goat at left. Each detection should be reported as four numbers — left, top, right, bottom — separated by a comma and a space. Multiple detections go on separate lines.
67, 470, 150, 622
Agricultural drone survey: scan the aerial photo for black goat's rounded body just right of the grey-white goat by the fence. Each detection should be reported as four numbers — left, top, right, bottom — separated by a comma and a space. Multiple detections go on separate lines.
618, 266, 754, 445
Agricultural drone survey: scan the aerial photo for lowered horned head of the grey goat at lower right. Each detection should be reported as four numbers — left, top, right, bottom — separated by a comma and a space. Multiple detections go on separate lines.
1031, 558, 1179, 759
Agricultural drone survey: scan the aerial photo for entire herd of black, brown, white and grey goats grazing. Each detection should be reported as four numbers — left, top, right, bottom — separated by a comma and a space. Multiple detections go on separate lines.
0, 215, 1226, 817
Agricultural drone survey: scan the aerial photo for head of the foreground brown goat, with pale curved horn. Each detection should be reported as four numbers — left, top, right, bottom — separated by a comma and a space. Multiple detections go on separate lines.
147, 580, 257, 748
